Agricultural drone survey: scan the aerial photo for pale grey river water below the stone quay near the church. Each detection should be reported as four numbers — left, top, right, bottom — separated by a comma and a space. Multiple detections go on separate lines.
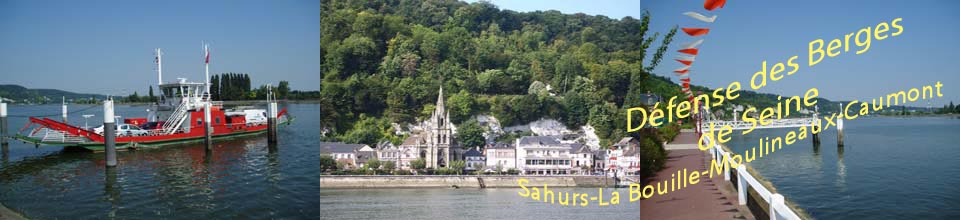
320, 188, 640, 220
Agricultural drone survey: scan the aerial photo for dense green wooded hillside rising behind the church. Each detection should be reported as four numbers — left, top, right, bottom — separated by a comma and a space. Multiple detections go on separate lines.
321, 0, 679, 146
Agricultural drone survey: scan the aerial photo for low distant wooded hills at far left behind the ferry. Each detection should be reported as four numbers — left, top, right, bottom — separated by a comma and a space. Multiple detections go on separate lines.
0, 85, 104, 104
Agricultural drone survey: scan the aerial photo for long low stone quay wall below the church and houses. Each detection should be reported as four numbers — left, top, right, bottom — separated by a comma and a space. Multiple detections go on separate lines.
320, 175, 614, 188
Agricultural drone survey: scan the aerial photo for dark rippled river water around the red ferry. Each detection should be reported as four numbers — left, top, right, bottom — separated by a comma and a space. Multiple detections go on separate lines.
0, 104, 320, 219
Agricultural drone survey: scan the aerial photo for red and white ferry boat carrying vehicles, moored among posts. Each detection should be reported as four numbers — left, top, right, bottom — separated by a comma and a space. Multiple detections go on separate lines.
16, 46, 292, 151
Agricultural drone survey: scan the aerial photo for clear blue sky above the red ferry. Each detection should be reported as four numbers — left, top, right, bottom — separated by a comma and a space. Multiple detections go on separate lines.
0, 0, 320, 95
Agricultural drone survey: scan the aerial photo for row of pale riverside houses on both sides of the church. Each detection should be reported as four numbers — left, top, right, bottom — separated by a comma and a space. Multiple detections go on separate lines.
320, 136, 642, 175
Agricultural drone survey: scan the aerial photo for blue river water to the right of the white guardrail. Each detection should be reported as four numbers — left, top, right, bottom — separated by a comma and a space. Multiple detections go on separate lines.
726, 117, 960, 219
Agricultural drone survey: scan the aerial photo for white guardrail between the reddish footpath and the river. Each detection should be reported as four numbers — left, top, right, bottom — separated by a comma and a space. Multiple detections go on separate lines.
705, 139, 801, 220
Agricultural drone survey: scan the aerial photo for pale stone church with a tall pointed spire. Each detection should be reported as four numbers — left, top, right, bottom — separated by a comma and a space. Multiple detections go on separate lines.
399, 87, 463, 169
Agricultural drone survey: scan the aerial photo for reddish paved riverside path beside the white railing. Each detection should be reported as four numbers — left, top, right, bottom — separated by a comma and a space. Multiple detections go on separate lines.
640, 131, 754, 219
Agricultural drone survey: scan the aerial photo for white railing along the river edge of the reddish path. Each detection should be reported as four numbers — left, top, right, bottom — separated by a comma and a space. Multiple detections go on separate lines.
704, 138, 802, 219
